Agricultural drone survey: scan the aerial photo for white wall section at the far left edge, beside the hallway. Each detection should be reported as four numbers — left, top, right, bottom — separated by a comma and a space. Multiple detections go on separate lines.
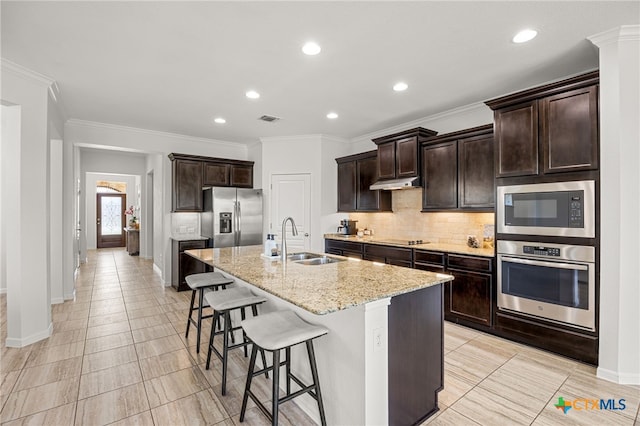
1, 60, 53, 347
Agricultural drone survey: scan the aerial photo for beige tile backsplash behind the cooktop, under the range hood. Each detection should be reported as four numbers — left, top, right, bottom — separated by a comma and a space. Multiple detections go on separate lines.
349, 189, 494, 244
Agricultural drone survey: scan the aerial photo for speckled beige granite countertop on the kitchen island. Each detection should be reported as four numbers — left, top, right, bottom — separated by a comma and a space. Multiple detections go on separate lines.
185, 246, 453, 315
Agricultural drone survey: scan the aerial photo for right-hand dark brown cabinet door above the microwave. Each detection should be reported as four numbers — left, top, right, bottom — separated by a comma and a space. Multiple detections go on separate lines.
540, 86, 598, 173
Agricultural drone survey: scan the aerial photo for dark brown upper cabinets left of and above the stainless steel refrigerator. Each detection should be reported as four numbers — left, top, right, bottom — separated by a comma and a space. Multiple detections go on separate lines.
169, 153, 253, 212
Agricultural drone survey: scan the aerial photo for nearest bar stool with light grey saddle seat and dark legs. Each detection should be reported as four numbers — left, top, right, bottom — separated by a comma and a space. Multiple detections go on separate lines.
240, 311, 329, 426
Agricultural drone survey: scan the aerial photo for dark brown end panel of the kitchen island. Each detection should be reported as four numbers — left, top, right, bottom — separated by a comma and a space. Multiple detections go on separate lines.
388, 284, 444, 425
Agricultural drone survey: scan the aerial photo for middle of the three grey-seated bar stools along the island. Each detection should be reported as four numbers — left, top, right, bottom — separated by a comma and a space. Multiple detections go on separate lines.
205, 287, 269, 395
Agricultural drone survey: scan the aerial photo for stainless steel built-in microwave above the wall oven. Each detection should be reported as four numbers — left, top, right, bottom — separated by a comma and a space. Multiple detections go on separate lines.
496, 180, 596, 238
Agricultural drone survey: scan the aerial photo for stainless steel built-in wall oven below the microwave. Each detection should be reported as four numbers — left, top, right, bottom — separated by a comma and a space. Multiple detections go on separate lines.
497, 240, 595, 331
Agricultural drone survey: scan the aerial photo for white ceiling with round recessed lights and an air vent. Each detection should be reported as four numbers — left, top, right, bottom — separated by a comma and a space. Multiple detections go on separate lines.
1, 0, 640, 143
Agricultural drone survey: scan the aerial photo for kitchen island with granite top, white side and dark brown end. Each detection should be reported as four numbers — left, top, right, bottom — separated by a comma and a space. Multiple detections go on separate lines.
185, 246, 453, 425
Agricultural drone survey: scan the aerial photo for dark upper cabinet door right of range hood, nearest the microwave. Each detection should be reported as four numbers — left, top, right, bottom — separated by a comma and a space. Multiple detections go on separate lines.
458, 135, 495, 209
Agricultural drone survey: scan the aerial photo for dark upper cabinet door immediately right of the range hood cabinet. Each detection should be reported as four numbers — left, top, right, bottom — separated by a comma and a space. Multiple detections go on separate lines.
422, 141, 458, 210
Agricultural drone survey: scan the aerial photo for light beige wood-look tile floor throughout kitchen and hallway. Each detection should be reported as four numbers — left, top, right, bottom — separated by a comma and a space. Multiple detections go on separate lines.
0, 249, 640, 426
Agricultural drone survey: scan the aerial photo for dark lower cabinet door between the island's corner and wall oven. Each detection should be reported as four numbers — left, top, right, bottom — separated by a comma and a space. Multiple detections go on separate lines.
445, 269, 492, 326
